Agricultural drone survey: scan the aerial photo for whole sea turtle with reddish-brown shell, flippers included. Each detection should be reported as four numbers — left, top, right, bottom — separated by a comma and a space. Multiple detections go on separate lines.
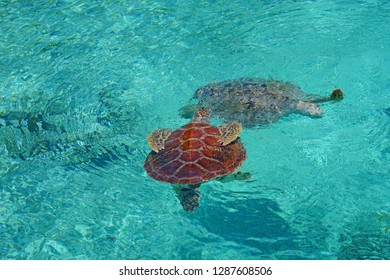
144, 108, 246, 211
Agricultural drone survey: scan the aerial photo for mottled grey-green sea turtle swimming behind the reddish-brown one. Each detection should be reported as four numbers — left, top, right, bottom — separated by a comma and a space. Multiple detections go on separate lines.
181, 78, 343, 127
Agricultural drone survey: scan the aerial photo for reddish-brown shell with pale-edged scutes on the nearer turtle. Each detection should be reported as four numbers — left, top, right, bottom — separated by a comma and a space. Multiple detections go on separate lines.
144, 123, 246, 185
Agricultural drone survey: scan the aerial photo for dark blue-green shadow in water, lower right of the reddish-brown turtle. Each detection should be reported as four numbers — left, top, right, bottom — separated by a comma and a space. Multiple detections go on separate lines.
193, 194, 308, 259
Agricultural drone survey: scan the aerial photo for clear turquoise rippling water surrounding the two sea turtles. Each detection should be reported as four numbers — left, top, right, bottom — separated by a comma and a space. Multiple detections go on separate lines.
0, 0, 390, 259
